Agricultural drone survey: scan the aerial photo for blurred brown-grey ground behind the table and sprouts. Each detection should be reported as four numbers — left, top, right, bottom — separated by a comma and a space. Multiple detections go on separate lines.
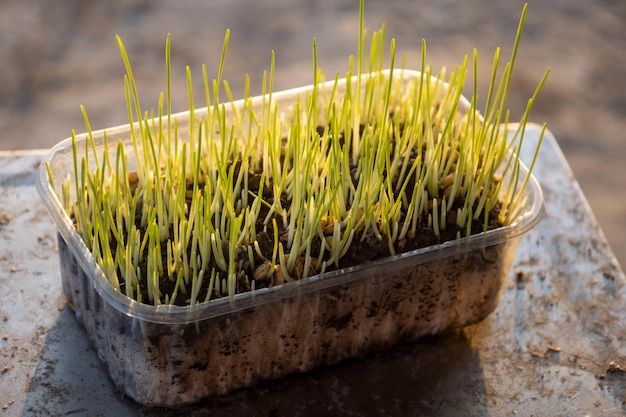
0, 0, 626, 265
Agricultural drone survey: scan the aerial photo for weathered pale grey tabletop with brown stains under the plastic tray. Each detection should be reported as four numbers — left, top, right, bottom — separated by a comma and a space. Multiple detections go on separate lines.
0, 126, 626, 416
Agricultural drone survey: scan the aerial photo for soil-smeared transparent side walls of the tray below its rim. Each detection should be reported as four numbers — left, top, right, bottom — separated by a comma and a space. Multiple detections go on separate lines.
59, 234, 519, 407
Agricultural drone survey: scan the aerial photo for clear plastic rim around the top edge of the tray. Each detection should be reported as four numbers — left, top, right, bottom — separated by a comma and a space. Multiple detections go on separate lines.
36, 70, 545, 325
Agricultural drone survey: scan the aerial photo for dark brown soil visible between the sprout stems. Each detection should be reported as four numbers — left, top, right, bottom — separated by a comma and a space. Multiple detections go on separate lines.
84, 121, 501, 306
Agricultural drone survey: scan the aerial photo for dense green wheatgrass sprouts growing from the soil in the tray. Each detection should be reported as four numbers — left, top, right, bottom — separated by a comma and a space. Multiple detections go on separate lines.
48, 1, 548, 306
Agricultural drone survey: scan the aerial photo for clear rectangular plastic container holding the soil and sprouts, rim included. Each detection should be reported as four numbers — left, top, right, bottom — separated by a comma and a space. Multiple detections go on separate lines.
37, 71, 543, 407
